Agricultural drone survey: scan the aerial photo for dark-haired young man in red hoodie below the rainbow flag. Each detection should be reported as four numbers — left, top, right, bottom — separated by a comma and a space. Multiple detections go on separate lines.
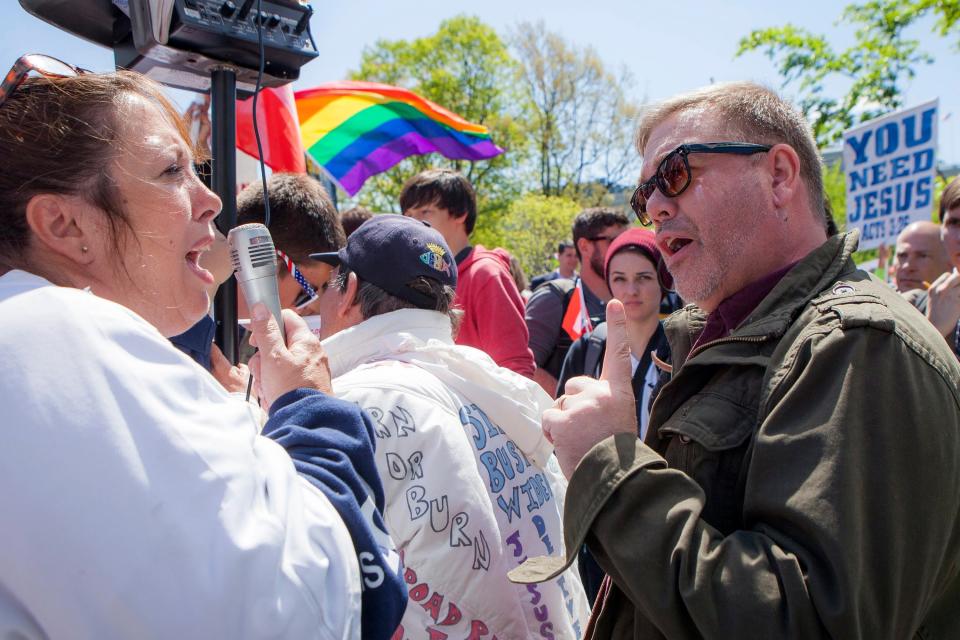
400, 169, 536, 378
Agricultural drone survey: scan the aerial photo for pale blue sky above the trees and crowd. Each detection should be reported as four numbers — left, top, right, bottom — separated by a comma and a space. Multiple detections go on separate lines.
7, 0, 960, 163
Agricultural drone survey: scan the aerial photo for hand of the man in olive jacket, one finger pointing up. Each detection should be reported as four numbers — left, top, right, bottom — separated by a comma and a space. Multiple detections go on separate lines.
542, 300, 637, 479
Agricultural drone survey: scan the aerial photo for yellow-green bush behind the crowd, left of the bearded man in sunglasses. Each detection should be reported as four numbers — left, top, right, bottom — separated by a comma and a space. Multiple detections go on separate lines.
472, 193, 581, 277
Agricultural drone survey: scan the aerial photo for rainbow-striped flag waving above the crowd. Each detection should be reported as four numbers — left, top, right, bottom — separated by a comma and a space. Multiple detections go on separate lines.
294, 81, 503, 196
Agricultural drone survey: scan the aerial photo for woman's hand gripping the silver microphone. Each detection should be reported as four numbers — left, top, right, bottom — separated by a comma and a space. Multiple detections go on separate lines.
250, 302, 333, 410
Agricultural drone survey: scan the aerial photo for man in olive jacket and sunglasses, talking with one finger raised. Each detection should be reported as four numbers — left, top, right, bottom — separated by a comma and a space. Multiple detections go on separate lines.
511, 83, 960, 640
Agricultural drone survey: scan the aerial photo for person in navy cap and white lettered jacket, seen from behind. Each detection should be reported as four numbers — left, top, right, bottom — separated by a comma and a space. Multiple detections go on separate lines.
311, 214, 590, 638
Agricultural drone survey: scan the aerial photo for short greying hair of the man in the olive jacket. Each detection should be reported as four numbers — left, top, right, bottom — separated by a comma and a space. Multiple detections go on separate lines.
636, 82, 827, 226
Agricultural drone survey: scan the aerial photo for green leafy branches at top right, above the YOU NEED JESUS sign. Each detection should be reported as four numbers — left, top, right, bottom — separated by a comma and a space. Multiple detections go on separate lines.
736, 0, 960, 147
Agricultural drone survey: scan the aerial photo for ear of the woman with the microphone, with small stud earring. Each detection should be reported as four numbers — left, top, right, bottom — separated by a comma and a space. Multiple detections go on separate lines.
26, 193, 95, 264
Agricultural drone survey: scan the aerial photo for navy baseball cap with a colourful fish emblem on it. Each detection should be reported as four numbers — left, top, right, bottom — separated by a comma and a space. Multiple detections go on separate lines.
310, 214, 457, 309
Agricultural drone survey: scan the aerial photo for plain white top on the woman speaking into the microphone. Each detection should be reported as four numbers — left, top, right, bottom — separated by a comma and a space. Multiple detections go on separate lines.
0, 271, 360, 640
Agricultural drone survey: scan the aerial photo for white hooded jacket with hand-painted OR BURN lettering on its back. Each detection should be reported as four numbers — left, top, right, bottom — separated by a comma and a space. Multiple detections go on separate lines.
324, 309, 590, 640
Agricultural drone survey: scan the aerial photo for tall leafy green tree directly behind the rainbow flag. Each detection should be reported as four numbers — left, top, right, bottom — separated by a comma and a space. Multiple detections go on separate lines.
351, 16, 527, 219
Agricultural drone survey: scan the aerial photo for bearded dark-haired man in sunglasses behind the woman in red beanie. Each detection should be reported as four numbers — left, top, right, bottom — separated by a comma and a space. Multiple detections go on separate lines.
524, 207, 630, 396
